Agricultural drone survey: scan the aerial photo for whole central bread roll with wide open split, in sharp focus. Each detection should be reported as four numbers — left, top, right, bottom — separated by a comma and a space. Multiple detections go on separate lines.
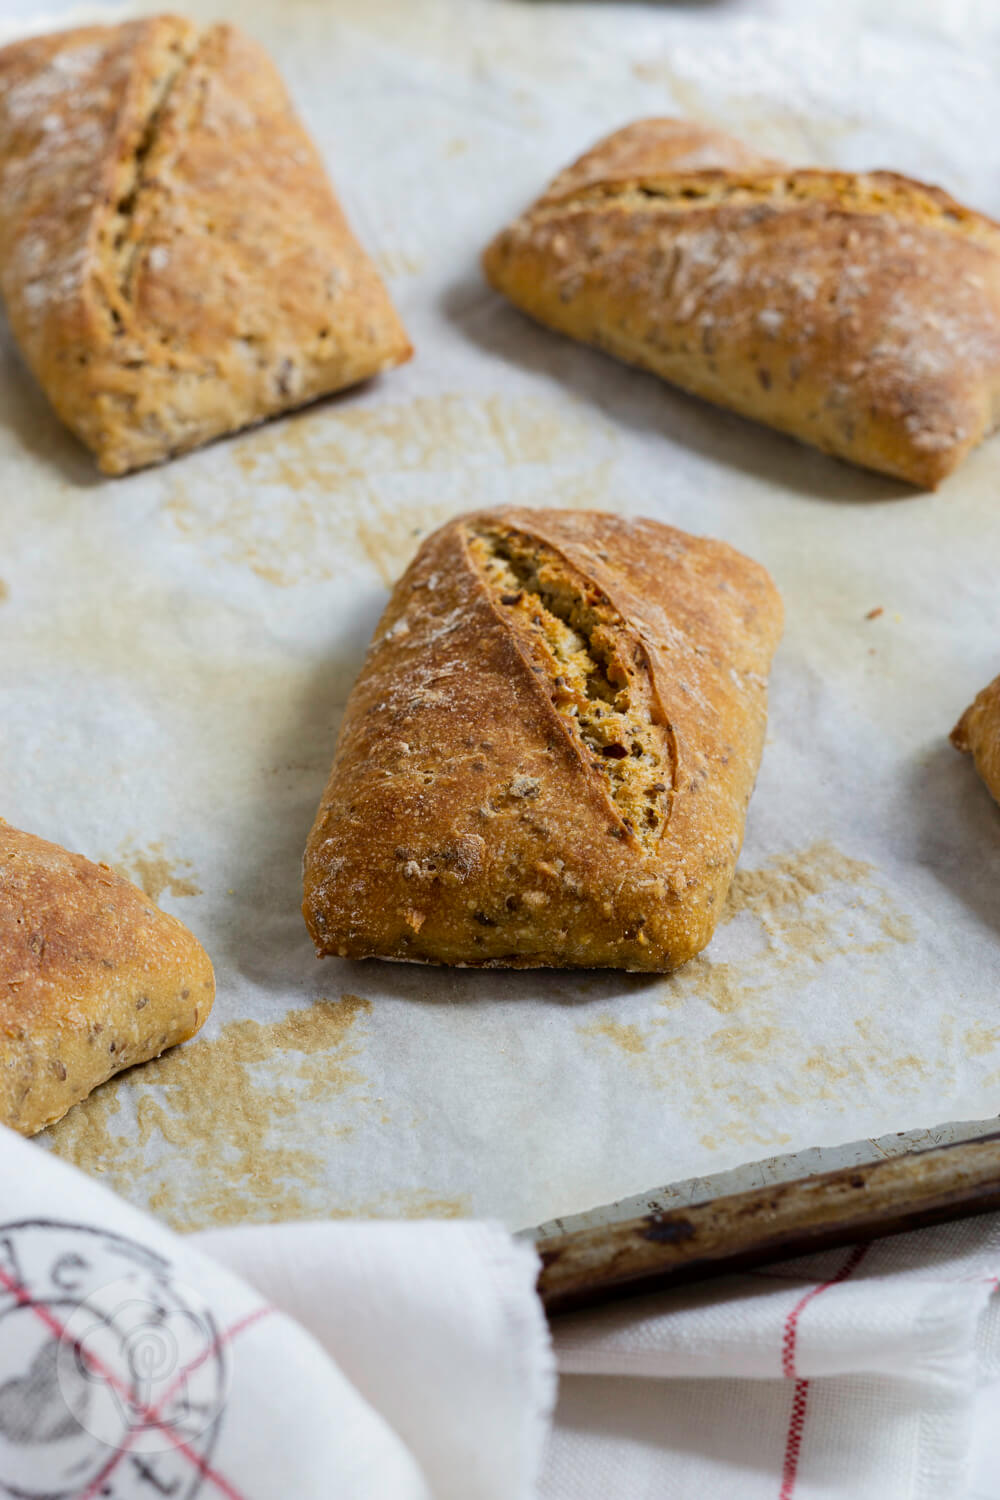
303, 509, 781, 971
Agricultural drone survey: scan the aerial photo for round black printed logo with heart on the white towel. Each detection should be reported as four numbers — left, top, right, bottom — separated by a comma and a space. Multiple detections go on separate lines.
0, 1220, 229, 1500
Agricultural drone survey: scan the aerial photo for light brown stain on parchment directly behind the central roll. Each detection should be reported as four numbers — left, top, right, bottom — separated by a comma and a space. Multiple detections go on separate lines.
162, 395, 618, 588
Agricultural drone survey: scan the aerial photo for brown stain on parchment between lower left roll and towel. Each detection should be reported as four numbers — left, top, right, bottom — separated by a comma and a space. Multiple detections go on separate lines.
46, 995, 374, 1230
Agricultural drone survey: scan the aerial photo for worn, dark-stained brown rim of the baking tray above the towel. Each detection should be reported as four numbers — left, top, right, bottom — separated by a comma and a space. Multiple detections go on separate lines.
536, 1121, 1000, 1317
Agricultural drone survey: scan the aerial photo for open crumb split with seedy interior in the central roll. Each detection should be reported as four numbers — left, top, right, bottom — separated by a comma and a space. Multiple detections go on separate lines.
469, 527, 673, 849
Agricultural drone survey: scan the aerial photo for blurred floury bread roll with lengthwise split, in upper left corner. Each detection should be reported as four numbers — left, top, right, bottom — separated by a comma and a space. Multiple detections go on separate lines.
0, 15, 411, 474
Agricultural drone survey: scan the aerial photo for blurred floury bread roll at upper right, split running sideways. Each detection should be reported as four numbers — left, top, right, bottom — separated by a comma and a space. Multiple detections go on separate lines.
484, 120, 1000, 488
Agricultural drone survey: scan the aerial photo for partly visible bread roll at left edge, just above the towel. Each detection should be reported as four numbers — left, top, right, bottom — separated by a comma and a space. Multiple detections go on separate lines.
0, 819, 216, 1136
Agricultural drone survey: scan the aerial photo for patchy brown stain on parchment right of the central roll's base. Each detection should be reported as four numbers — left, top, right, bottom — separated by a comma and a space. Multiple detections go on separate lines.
579, 842, 921, 1149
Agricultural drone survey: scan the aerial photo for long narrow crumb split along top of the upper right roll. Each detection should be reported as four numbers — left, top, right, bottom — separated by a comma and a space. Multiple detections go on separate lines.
534, 168, 997, 239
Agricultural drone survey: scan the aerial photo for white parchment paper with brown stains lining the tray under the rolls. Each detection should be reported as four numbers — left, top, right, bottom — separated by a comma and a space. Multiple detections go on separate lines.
0, 0, 1000, 1229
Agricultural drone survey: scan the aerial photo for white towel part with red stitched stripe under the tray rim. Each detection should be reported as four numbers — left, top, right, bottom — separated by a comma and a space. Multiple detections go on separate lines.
543, 1217, 1000, 1500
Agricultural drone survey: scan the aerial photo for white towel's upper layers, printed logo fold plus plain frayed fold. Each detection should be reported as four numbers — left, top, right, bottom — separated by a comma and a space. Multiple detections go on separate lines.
0, 1128, 553, 1500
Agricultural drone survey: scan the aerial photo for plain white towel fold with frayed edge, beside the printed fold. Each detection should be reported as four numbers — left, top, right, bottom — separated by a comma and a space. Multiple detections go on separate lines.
193, 1220, 555, 1500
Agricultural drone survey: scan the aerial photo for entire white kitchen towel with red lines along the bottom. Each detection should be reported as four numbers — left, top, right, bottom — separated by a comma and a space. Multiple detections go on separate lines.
0, 1130, 1000, 1500
